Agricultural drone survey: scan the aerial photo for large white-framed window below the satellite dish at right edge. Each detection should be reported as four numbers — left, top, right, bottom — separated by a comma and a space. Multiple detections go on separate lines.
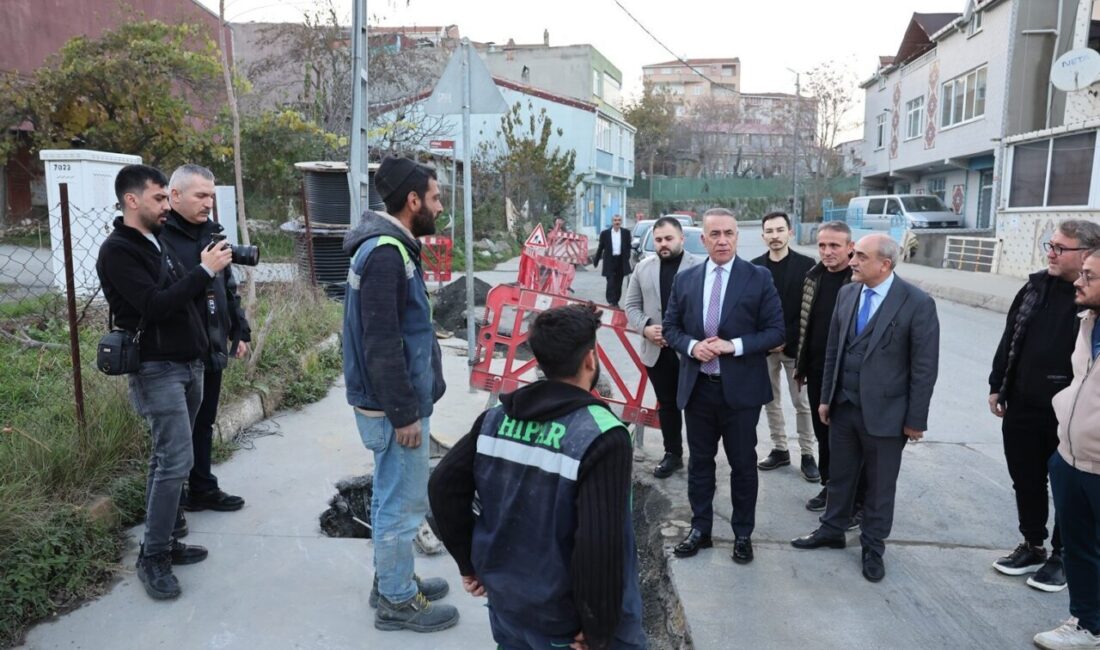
1009, 131, 1097, 208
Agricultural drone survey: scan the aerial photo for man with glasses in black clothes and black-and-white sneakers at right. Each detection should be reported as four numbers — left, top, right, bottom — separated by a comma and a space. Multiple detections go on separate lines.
989, 220, 1100, 592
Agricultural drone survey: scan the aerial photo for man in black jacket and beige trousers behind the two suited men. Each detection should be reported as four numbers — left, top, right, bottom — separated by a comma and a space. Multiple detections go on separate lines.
752, 212, 821, 483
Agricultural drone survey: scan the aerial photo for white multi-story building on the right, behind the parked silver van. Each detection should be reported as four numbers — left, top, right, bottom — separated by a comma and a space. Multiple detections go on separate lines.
861, 0, 1100, 277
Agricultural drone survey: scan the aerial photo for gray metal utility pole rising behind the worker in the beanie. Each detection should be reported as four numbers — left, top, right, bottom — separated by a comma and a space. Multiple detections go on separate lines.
348, 0, 371, 228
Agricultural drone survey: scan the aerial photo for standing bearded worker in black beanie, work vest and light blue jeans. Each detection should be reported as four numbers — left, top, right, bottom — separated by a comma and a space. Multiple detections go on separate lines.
343, 157, 459, 632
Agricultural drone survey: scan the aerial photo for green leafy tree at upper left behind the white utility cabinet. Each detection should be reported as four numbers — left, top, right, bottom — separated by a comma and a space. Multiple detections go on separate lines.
0, 21, 221, 167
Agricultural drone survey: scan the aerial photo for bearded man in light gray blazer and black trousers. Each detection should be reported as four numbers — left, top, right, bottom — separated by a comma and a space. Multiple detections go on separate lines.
623, 217, 700, 478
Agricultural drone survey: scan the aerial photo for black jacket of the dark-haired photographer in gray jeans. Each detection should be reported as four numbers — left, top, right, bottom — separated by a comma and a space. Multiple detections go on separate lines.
96, 217, 210, 362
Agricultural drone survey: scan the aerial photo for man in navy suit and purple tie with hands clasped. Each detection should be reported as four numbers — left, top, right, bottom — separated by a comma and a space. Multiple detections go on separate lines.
663, 208, 787, 564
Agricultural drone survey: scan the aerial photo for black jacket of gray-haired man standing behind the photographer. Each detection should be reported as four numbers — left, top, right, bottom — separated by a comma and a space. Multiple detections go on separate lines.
161, 210, 252, 371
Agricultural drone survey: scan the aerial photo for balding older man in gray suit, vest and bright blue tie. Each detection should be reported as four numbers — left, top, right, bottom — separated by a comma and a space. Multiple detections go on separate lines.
791, 234, 939, 582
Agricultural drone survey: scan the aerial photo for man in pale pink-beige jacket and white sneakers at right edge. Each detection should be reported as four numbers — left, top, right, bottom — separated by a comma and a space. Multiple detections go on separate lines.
1035, 250, 1100, 650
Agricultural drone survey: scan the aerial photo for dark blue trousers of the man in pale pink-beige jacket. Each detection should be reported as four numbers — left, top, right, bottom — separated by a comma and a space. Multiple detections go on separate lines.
1047, 452, 1100, 634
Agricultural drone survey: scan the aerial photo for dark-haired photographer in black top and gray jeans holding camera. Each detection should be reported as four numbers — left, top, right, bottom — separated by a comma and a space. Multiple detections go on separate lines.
96, 165, 232, 599
